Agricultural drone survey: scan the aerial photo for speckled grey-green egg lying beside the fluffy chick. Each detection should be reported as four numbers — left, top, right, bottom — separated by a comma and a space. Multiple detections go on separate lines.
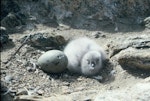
38, 50, 68, 73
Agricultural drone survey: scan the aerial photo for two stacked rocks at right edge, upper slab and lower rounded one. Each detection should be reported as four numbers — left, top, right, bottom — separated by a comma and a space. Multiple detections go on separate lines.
108, 34, 150, 69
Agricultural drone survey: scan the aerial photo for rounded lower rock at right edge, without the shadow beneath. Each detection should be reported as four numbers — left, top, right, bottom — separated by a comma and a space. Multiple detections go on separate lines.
117, 48, 150, 70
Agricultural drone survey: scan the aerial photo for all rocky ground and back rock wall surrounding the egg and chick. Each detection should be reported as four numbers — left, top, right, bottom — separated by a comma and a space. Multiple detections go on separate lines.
0, 0, 150, 101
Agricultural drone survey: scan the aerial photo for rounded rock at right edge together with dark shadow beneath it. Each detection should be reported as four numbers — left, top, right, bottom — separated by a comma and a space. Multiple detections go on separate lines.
118, 48, 150, 78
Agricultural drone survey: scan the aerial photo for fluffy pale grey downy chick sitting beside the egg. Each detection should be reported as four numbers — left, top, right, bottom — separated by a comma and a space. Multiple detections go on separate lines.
64, 37, 106, 76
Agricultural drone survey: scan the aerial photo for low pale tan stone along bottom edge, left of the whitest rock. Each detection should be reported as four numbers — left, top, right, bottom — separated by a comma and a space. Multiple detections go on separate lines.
14, 90, 98, 101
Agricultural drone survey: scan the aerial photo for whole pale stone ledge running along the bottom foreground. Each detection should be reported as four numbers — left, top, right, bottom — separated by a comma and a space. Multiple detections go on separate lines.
12, 81, 150, 101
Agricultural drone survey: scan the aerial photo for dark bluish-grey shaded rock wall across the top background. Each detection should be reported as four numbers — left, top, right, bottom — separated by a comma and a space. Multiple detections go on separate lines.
1, 0, 150, 30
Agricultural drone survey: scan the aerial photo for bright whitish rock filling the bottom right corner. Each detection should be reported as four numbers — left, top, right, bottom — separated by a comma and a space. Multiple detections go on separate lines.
94, 82, 150, 101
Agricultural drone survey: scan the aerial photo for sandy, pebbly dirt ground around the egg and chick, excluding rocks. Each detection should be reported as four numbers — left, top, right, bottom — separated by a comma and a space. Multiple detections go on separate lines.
1, 25, 149, 100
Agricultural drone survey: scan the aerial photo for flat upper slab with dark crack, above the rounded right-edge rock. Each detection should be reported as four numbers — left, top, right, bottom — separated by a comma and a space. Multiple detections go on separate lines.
108, 34, 150, 57
